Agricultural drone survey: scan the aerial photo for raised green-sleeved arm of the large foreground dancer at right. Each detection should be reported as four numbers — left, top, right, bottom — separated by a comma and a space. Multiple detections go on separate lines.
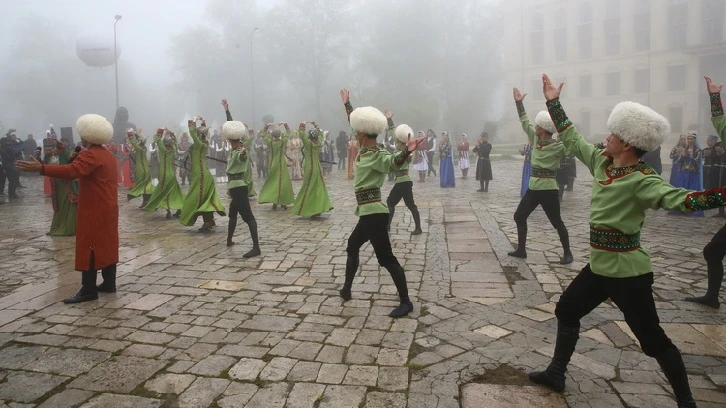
542, 75, 602, 173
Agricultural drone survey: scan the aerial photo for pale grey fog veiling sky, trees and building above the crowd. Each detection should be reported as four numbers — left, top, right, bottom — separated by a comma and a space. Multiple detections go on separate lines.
0, 0, 726, 147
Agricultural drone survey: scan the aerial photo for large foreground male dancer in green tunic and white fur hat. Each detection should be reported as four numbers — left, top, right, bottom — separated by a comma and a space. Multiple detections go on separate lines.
529, 75, 726, 408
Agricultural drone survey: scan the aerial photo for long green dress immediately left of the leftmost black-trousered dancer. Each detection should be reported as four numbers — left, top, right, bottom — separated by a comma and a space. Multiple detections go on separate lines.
179, 124, 226, 227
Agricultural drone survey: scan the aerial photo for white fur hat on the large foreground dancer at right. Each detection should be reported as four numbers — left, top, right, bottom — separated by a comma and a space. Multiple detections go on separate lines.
608, 101, 671, 152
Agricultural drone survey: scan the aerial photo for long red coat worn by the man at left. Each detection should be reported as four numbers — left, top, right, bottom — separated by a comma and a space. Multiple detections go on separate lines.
43, 145, 118, 271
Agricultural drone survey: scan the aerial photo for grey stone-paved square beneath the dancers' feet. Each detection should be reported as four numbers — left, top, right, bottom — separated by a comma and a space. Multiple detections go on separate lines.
0, 161, 726, 408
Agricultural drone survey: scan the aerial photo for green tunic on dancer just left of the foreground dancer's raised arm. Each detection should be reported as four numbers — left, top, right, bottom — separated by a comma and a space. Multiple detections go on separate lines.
517, 101, 566, 190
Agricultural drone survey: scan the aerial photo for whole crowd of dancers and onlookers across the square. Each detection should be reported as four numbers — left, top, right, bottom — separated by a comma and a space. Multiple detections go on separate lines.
7, 71, 726, 407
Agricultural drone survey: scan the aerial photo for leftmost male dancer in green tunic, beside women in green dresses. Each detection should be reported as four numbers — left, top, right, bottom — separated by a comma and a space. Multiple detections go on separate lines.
222, 121, 260, 258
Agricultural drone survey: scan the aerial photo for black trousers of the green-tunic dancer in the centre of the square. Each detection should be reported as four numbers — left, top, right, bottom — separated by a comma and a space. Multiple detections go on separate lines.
345, 213, 409, 302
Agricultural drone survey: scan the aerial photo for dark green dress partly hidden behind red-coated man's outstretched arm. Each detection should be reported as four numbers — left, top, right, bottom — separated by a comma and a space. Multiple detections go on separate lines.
48, 143, 78, 237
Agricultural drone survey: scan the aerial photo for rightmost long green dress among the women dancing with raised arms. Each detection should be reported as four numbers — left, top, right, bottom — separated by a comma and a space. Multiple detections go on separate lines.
292, 128, 333, 217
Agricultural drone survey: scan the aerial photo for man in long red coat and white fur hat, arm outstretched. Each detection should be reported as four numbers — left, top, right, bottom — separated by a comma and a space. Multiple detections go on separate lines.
18, 114, 118, 303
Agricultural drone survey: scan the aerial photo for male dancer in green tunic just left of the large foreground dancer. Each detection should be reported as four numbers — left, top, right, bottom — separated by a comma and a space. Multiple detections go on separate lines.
509, 88, 572, 264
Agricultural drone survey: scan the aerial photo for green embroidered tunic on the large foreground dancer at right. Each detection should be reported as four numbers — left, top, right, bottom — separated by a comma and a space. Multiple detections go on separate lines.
547, 99, 725, 278
